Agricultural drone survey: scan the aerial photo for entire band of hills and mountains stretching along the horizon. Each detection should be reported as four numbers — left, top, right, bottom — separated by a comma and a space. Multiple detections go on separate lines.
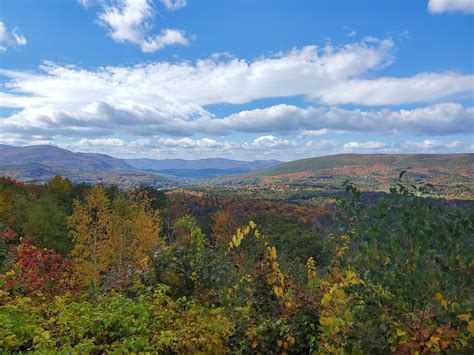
0, 145, 474, 196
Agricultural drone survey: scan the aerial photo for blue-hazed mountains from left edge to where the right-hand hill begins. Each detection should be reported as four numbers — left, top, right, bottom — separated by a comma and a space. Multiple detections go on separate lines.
0, 144, 280, 182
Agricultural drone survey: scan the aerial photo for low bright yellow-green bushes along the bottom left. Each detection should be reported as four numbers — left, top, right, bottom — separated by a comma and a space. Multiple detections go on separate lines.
0, 286, 233, 353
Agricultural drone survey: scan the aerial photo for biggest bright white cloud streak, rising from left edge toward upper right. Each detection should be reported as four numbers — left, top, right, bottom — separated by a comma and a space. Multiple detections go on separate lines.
0, 41, 396, 115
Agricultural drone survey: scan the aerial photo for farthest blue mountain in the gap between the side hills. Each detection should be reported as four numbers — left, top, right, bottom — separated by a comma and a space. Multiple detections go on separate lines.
124, 158, 281, 179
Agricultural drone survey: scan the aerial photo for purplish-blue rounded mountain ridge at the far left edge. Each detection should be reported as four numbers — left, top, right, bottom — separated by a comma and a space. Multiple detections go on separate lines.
0, 144, 135, 170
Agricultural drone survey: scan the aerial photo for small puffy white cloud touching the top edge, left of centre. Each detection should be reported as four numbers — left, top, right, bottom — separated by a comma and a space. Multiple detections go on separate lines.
79, 0, 189, 53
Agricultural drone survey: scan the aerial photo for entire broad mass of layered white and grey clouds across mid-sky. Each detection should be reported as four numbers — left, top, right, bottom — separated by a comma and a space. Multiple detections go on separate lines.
0, 38, 474, 159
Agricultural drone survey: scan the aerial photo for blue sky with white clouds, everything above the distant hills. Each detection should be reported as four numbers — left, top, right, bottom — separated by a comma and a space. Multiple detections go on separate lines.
0, 0, 474, 161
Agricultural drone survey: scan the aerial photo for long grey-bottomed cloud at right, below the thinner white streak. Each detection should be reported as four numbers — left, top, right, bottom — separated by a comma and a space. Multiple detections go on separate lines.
198, 103, 474, 136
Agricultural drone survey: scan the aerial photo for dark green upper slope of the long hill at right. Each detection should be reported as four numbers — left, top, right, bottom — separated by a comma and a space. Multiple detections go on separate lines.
252, 153, 474, 176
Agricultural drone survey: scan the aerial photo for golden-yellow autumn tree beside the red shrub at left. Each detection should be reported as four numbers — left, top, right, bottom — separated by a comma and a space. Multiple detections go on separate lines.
68, 187, 160, 290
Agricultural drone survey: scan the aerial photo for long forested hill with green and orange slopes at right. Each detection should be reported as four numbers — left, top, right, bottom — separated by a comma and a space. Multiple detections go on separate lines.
216, 153, 474, 198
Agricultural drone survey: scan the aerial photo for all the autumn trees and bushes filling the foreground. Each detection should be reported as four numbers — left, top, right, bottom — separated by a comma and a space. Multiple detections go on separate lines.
0, 172, 474, 354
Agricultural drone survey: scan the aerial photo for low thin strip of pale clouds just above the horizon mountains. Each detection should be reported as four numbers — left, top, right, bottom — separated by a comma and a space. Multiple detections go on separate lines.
52, 135, 474, 160
